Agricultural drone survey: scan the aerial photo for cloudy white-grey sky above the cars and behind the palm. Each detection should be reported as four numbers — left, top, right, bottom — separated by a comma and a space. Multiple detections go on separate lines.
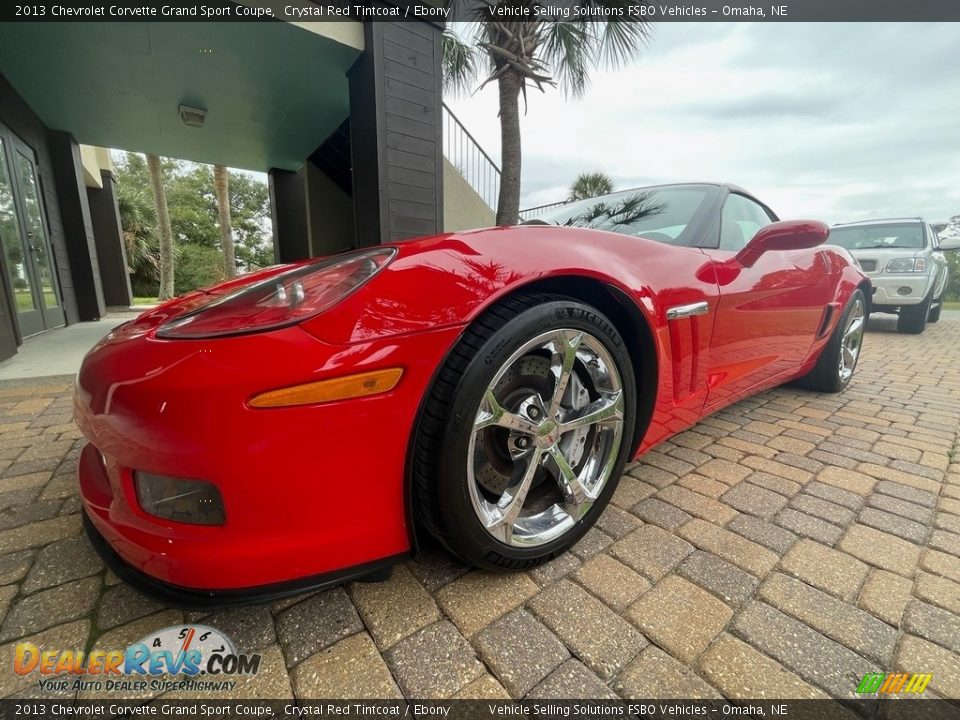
447, 23, 960, 223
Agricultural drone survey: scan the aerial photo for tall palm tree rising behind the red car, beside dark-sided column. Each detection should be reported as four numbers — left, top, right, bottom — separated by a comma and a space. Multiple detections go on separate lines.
442, 12, 650, 225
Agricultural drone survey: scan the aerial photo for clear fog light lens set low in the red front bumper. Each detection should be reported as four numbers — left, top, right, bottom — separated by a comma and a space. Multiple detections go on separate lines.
133, 472, 225, 525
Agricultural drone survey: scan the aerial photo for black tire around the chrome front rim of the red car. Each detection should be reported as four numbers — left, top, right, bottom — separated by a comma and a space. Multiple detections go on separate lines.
412, 295, 637, 571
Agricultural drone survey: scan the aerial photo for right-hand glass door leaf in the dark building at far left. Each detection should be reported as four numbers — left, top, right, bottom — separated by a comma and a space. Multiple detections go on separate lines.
4, 132, 66, 337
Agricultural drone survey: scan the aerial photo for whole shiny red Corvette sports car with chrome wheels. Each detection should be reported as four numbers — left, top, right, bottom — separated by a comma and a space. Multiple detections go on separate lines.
75, 184, 871, 604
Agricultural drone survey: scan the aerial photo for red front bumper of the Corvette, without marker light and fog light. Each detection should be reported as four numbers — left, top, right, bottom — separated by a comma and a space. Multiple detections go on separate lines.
74, 327, 460, 592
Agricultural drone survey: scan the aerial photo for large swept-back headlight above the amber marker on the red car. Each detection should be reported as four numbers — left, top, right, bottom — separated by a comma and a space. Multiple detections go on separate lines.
157, 248, 397, 339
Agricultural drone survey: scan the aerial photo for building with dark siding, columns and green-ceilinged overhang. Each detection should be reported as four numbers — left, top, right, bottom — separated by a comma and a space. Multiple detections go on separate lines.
0, 16, 499, 360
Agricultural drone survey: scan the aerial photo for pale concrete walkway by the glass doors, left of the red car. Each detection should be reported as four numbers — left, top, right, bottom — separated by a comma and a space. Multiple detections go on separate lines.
0, 311, 139, 380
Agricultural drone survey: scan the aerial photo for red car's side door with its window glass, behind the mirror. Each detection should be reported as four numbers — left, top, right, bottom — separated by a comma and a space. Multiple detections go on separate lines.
702, 192, 829, 413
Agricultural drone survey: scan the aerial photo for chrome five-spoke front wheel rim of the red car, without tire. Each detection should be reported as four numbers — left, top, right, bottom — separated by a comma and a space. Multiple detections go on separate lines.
466, 328, 624, 547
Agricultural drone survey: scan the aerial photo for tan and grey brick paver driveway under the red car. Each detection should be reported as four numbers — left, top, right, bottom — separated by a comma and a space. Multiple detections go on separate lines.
0, 317, 960, 698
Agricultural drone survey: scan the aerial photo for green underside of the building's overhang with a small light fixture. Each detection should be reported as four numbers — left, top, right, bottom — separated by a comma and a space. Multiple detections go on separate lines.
0, 22, 361, 171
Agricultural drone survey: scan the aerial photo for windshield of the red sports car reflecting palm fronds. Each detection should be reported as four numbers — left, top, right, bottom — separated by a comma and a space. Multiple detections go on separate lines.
527, 185, 710, 245
